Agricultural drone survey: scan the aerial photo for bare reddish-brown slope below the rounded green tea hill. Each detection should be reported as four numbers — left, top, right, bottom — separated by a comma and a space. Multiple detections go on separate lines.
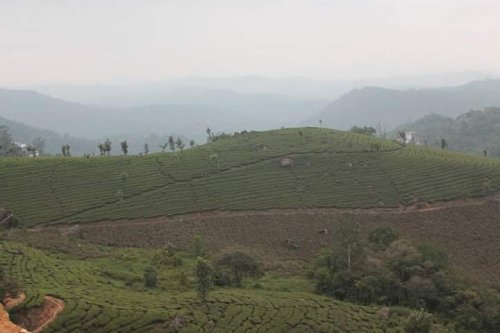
28, 198, 500, 286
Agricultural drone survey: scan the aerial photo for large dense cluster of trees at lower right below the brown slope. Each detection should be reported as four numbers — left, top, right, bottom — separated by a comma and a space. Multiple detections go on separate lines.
310, 220, 500, 330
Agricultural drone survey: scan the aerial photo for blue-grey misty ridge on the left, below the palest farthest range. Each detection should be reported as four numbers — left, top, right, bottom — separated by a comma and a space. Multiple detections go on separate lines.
0, 89, 324, 141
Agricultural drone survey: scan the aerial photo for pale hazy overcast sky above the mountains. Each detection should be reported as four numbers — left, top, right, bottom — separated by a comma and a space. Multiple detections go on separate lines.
0, 0, 500, 86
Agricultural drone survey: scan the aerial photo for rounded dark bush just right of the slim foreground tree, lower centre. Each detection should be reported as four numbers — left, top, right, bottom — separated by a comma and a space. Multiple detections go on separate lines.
214, 251, 263, 287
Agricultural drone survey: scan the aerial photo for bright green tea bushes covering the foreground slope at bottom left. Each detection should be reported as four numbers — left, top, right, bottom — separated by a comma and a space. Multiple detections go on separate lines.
0, 242, 418, 333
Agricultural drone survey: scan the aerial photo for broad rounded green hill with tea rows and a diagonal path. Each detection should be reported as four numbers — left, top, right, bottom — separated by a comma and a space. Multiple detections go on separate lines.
0, 128, 500, 226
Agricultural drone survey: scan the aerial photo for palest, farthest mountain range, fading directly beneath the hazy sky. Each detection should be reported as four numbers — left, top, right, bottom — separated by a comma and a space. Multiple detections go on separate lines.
31, 71, 500, 103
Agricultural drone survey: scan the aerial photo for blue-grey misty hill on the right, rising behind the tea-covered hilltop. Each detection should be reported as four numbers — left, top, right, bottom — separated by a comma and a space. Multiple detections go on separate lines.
308, 80, 500, 130
